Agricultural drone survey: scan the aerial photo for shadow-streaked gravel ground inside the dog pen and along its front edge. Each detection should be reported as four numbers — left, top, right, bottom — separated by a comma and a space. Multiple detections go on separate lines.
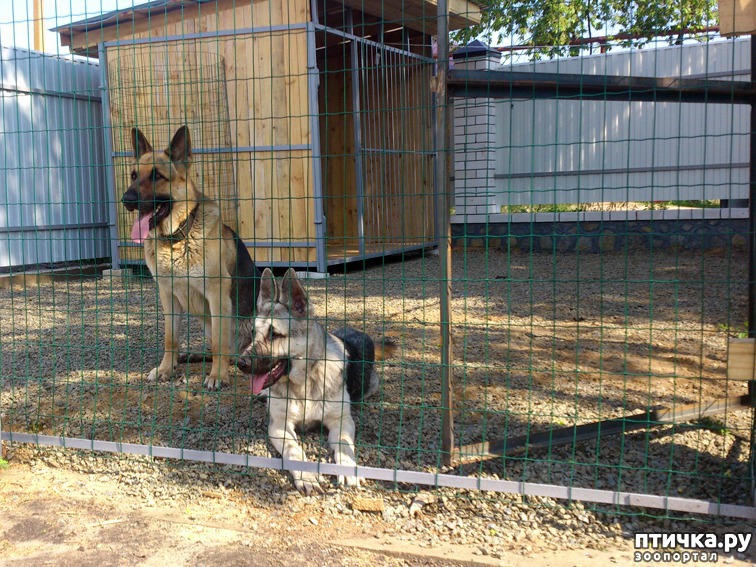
0, 248, 751, 520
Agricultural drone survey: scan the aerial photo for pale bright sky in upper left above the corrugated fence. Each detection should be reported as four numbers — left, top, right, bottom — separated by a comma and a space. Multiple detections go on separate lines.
0, 0, 139, 55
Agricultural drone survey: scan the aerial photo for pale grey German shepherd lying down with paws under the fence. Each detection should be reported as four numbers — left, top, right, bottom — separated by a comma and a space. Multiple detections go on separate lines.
237, 268, 396, 494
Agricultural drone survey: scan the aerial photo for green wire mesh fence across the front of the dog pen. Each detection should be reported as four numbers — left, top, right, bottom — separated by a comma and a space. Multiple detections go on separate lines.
0, 0, 755, 518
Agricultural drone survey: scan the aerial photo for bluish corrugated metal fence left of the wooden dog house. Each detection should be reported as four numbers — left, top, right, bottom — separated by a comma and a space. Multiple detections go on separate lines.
0, 47, 110, 271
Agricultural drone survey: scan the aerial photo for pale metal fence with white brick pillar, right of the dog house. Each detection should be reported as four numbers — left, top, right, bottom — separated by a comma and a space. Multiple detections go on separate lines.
455, 39, 750, 220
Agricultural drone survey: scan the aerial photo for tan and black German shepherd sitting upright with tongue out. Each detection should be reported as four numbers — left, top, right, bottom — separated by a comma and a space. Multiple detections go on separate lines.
122, 126, 260, 390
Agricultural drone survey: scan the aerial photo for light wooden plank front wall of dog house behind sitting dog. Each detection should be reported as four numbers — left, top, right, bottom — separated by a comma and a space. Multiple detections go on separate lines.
107, 0, 315, 262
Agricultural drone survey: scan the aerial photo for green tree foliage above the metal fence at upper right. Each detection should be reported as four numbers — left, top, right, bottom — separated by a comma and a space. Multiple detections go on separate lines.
453, 0, 717, 58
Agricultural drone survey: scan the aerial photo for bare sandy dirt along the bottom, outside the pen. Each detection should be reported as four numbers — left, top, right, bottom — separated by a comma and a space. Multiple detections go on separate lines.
0, 462, 753, 567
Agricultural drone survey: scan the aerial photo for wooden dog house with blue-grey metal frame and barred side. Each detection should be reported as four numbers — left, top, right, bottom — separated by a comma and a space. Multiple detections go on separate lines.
55, 0, 480, 271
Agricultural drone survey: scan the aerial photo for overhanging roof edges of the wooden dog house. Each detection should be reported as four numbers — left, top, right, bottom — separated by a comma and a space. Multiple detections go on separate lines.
52, 0, 481, 57
